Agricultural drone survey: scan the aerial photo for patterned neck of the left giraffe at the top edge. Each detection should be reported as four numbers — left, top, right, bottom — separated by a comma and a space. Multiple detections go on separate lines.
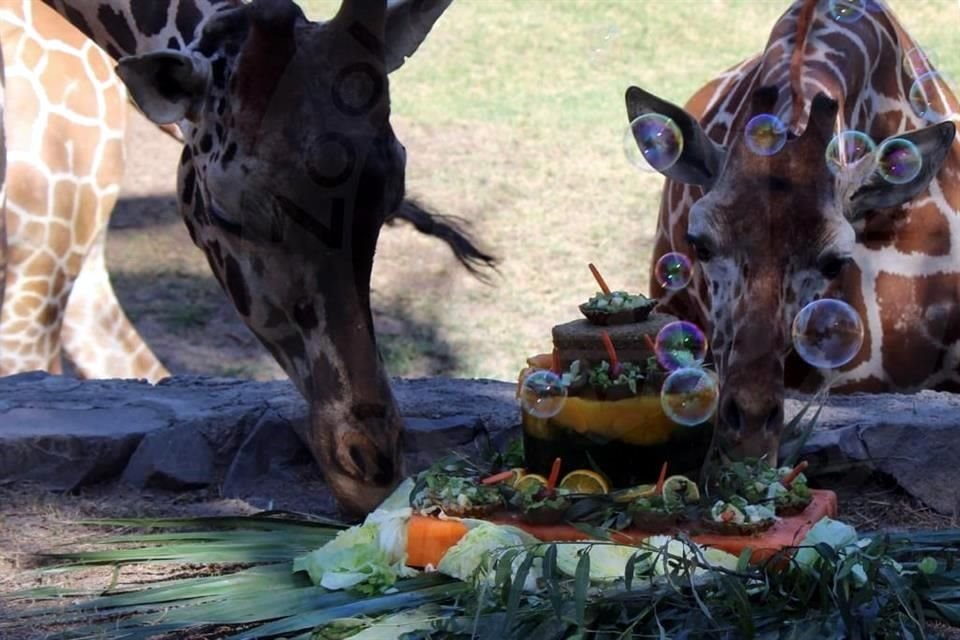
44, 0, 242, 59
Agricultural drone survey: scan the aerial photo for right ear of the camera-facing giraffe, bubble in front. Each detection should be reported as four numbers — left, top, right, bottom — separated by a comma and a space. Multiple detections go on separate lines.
848, 121, 957, 220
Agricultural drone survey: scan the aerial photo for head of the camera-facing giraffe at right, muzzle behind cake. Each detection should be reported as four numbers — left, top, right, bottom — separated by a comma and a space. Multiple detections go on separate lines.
626, 87, 955, 464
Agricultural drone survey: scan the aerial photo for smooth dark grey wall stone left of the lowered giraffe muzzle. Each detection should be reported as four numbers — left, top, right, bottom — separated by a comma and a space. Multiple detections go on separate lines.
123, 427, 214, 491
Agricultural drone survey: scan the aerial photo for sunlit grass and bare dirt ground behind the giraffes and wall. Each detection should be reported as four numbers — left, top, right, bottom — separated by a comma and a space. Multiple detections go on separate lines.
108, 0, 960, 380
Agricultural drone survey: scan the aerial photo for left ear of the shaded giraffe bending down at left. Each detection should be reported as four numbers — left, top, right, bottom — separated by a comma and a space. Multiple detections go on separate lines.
117, 51, 210, 124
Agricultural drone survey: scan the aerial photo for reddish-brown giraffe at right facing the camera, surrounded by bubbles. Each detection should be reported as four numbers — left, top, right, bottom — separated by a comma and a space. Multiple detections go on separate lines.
626, 0, 960, 464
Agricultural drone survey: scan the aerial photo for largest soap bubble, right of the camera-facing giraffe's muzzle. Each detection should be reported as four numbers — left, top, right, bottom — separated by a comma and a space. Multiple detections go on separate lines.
793, 298, 863, 369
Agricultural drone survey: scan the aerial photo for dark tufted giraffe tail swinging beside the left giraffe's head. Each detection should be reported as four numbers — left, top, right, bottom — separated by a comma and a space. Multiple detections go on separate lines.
385, 199, 500, 284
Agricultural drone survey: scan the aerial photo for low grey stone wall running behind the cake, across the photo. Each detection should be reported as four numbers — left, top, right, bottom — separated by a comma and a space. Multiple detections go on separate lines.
0, 373, 960, 513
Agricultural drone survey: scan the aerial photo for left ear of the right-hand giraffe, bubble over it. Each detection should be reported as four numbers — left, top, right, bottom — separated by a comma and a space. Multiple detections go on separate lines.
626, 87, 724, 189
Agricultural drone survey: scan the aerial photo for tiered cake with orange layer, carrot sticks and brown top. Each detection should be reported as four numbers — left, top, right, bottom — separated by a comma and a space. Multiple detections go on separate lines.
518, 292, 712, 487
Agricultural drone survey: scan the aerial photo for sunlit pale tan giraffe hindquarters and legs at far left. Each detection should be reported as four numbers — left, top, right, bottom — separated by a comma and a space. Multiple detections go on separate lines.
0, 0, 168, 381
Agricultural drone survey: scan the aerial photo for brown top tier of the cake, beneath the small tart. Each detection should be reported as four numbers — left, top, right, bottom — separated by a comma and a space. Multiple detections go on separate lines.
553, 313, 677, 367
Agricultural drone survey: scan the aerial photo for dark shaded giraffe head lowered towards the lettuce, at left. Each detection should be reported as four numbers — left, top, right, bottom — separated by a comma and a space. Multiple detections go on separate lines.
118, 0, 450, 513
